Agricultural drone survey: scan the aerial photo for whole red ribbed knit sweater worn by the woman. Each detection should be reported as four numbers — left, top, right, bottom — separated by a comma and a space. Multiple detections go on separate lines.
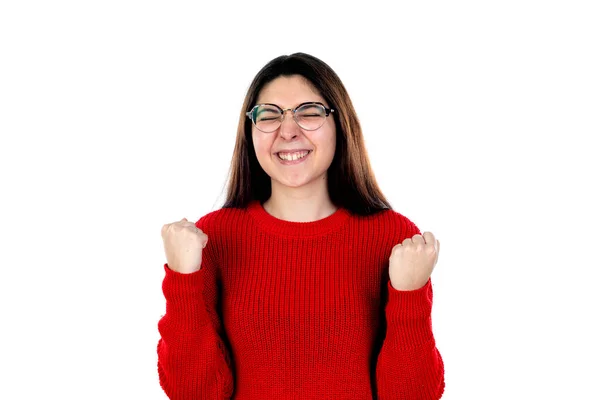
158, 200, 444, 400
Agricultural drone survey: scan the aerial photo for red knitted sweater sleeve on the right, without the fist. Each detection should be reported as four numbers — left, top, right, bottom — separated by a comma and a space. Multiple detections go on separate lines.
376, 221, 445, 400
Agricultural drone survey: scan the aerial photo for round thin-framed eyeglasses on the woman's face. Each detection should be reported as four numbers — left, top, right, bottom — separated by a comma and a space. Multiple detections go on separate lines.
246, 102, 335, 133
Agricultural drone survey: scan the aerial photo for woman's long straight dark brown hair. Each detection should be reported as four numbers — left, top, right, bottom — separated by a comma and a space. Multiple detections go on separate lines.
223, 53, 392, 215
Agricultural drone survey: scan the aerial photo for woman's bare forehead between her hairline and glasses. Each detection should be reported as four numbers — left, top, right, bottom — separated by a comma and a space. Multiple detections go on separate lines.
257, 75, 325, 108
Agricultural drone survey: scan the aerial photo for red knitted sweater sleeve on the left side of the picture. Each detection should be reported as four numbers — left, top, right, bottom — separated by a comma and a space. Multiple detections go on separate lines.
157, 230, 234, 400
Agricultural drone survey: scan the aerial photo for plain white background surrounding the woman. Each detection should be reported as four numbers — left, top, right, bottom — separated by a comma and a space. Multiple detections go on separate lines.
0, 0, 600, 400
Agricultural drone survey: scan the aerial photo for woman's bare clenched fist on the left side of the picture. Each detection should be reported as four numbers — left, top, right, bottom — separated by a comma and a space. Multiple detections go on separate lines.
160, 218, 208, 274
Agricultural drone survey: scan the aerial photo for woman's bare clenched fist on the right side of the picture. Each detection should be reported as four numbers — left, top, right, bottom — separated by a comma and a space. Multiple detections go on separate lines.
390, 232, 440, 290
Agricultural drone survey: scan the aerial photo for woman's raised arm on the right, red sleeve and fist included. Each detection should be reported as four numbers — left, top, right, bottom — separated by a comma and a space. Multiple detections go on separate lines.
376, 219, 445, 400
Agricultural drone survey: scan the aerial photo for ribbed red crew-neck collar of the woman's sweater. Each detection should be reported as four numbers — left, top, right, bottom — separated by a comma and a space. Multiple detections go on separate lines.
248, 200, 350, 237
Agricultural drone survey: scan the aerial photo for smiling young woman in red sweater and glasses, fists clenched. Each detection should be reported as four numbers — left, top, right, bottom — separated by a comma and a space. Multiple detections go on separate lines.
158, 53, 445, 400
